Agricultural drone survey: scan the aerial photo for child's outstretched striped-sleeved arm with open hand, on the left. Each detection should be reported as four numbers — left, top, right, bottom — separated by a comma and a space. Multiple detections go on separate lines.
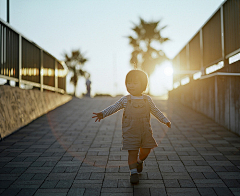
92, 97, 126, 122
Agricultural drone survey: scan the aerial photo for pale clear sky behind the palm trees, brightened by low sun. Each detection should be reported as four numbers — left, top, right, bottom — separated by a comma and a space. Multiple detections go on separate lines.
0, 0, 223, 96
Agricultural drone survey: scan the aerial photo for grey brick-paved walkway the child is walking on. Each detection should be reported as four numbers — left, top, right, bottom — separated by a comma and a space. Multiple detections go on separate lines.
0, 98, 240, 196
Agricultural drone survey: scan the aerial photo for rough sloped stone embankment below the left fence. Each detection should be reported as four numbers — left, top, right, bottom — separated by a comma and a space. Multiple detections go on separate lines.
0, 86, 72, 138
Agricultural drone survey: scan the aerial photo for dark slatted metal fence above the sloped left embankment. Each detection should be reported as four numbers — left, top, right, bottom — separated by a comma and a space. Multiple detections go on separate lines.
0, 19, 67, 93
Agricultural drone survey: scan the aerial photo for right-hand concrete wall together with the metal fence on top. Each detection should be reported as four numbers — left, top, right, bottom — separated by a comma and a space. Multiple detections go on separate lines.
169, 0, 240, 134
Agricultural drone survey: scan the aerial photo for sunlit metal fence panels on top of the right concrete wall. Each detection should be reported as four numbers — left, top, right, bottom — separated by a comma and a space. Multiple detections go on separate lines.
172, 0, 240, 83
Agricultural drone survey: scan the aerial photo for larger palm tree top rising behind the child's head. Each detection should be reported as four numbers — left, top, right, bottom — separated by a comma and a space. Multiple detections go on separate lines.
128, 18, 170, 92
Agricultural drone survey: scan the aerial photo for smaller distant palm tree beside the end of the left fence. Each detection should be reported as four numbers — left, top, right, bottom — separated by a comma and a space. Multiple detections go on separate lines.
64, 50, 88, 96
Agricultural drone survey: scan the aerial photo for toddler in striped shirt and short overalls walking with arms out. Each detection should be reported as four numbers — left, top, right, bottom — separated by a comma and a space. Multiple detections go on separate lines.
92, 70, 171, 184
